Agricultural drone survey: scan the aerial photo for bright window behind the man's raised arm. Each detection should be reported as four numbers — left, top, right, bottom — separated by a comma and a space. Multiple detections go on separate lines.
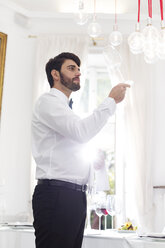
73, 51, 116, 228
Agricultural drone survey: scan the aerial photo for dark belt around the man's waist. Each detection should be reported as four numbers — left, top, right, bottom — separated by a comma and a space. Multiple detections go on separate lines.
37, 179, 87, 192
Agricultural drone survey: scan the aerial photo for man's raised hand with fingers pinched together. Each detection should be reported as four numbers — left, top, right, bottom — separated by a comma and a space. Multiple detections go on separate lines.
109, 83, 130, 103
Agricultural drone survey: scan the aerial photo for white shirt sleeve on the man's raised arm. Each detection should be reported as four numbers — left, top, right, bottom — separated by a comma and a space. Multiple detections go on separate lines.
37, 97, 116, 143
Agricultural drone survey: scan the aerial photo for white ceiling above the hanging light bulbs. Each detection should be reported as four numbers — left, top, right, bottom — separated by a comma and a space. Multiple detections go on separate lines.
0, 0, 160, 19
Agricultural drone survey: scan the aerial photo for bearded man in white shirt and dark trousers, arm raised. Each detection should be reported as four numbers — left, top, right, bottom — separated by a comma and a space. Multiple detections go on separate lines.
32, 53, 129, 248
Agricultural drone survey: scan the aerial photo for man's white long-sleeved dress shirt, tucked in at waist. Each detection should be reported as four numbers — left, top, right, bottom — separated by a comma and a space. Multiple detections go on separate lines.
32, 88, 116, 185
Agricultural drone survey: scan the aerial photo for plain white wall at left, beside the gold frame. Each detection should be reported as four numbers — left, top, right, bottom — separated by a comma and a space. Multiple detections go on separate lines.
0, 6, 35, 220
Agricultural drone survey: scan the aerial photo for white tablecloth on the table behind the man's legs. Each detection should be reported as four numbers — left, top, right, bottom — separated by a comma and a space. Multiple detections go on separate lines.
0, 228, 165, 248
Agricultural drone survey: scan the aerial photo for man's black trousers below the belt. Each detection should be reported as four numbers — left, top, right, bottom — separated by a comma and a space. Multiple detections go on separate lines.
32, 185, 86, 248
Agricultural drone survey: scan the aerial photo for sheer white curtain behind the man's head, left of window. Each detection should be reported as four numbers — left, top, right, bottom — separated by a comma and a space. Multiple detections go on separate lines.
31, 35, 88, 199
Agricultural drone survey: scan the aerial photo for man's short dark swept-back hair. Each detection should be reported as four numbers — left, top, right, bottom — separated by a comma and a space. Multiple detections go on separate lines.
45, 53, 81, 88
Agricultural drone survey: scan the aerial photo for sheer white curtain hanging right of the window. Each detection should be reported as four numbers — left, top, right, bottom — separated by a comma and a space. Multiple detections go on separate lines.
125, 52, 154, 231
